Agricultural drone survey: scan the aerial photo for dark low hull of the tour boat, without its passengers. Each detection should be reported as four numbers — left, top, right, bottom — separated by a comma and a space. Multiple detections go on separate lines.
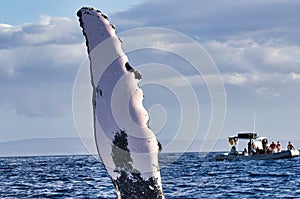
215, 150, 299, 161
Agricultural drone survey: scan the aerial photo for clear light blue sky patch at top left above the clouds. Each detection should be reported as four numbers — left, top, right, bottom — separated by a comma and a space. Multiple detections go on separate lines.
0, 0, 143, 25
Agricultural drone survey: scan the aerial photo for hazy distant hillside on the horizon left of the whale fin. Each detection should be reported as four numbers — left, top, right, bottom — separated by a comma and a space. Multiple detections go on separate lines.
0, 137, 97, 157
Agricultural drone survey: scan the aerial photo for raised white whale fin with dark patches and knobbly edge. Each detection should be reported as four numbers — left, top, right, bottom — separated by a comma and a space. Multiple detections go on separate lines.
77, 7, 164, 199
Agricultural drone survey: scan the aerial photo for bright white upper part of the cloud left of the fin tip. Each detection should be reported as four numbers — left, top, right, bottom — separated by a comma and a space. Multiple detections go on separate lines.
0, 15, 83, 49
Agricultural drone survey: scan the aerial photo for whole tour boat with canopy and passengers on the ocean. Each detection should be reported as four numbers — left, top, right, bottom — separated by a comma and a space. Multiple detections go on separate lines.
215, 132, 299, 161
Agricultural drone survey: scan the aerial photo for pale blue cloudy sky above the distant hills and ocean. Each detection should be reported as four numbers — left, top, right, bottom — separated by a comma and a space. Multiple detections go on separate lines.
0, 0, 300, 152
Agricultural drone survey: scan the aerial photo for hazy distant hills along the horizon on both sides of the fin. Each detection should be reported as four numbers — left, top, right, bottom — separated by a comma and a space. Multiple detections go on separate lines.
0, 137, 300, 157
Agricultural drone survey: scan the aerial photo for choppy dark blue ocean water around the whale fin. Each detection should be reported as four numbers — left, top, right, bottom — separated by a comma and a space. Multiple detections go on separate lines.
0, 153, 300, 198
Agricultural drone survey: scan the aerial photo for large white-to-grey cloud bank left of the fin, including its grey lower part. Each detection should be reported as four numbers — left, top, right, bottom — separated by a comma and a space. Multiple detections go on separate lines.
0, 16, 87, 117
